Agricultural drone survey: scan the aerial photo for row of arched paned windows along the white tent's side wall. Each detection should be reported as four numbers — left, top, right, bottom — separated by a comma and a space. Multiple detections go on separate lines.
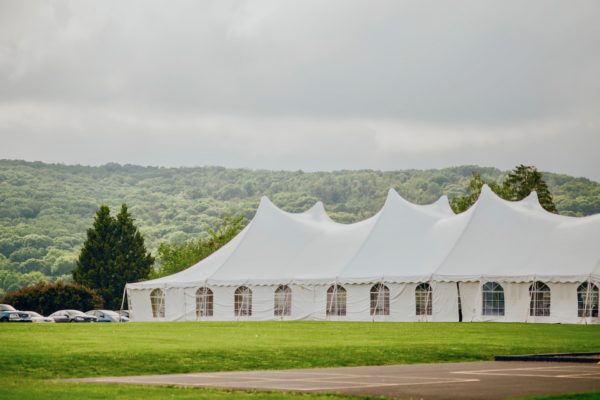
150, 281, 599, 318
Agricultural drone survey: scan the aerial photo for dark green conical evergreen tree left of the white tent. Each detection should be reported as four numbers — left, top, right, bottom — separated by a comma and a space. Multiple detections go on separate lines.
73, 204, 154, 309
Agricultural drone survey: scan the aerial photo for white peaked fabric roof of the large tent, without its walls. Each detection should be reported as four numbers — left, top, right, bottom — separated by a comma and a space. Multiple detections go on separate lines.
127, 186, 600, 290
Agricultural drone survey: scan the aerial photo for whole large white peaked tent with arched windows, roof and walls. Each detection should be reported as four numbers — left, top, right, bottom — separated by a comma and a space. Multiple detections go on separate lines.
126, 186, 600, 323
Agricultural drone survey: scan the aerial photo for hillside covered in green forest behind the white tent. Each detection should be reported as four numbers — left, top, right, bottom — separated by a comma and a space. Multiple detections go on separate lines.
0, 160, 600, 296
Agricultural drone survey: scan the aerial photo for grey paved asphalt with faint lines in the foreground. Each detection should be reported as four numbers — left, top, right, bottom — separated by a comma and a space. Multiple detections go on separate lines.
75, 361, 600, 399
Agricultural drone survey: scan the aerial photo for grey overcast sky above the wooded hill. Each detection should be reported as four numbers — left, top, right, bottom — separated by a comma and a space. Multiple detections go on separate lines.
0, 0, 600, 181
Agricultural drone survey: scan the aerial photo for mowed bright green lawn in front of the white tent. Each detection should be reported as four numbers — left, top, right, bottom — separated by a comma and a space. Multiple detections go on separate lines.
0, 322, 600, 400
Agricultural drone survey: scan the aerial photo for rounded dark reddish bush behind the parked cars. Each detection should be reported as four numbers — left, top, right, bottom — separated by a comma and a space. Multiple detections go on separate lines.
0, 282, 103, 315
